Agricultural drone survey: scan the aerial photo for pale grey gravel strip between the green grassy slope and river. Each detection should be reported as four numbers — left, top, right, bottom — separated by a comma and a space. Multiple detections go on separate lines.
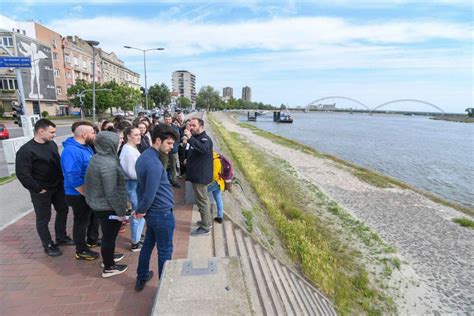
212, 113, 474, 313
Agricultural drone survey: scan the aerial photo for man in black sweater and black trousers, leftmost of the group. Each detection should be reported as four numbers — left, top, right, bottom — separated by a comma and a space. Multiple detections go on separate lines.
15, 119, 74, 257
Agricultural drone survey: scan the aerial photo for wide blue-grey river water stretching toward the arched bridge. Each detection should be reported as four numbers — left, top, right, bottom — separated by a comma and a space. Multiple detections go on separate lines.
242, 112, 474, 207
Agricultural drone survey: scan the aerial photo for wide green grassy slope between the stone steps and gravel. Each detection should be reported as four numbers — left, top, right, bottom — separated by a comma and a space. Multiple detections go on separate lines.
209, 115, 395, 314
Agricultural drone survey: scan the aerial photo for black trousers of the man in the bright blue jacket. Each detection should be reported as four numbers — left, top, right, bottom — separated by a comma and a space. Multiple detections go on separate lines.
66, 195, 92, 252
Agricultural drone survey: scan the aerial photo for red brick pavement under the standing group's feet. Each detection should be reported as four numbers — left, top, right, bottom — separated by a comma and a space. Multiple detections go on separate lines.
0, 179, 192, 315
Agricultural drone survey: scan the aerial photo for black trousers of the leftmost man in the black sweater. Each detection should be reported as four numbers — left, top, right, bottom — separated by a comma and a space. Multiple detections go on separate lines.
30, 184, 68, 246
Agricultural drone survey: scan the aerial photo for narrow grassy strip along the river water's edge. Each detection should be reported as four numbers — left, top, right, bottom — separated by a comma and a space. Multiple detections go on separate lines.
239, 123, 474, 216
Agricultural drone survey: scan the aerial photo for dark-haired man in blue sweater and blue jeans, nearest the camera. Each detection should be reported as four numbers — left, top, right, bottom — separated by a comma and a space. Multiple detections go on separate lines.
132, 125, 179, 292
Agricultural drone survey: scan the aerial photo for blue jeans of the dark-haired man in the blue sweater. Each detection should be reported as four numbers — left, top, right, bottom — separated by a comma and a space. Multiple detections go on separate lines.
137, 209, 176, 280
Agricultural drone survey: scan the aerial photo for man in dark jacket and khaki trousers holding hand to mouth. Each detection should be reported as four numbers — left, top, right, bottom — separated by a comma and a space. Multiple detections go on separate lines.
184, 118, 213, 236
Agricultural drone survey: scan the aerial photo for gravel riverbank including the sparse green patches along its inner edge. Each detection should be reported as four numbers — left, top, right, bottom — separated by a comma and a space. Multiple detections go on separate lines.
208, 113, 474, 314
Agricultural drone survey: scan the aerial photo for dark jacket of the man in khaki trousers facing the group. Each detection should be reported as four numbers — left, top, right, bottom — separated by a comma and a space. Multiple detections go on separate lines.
186, 132, 213, 184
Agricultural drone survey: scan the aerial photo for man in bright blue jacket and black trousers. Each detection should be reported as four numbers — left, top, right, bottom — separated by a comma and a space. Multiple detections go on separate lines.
61, 121, 99, 261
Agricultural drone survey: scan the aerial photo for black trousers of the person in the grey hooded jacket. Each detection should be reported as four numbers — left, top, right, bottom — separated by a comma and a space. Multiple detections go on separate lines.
95, 211, 122, 269
